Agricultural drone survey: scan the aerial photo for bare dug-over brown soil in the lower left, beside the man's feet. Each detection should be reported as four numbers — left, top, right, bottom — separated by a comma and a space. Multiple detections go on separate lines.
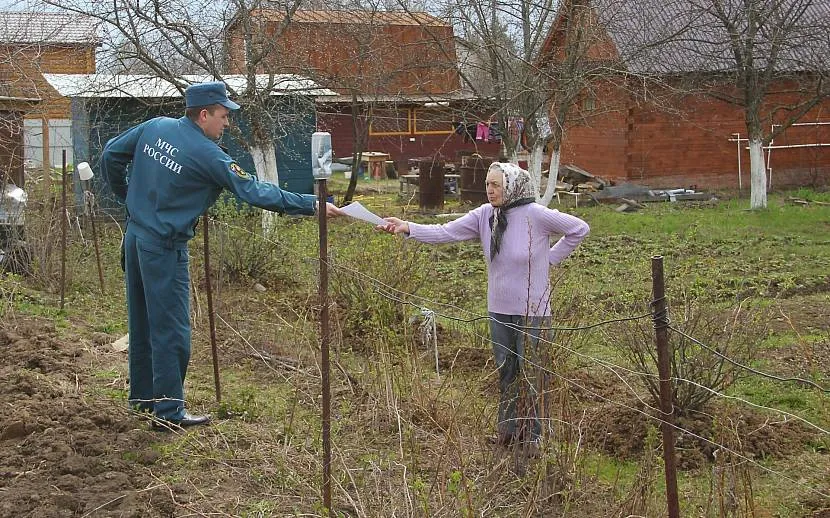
0, 320, 176, 517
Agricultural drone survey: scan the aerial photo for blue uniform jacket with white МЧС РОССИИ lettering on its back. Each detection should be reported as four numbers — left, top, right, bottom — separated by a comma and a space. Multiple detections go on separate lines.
101, 117, 316, 242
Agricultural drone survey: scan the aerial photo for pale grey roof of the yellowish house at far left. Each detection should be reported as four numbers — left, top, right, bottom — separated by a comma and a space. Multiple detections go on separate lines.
0, 12, 101, 45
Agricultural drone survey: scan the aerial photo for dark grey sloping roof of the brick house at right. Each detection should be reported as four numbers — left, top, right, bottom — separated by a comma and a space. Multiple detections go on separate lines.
546, 0, 830, 74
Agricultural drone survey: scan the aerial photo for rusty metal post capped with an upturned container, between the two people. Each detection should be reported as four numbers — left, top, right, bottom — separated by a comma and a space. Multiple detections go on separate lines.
317, 178, 331, 513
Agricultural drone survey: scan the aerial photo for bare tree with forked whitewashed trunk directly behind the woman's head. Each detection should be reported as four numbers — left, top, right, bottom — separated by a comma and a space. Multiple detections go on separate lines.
420, 0, 618, 205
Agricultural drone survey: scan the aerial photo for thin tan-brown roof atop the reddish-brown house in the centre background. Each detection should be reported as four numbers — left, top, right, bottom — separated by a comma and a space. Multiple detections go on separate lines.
255, 9, 450, 27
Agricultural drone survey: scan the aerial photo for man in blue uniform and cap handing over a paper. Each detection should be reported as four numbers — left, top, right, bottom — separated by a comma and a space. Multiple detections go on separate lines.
101, 82, 340, 426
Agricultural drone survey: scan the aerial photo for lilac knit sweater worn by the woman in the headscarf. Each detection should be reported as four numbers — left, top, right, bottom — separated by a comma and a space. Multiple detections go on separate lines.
409, 203, 590, 316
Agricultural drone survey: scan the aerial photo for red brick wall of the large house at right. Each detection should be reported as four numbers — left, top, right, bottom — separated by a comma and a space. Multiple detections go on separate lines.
562, 83, 830, 189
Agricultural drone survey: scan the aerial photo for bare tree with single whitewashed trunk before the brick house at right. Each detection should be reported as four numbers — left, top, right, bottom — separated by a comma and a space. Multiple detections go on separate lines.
610, 0, 830, 209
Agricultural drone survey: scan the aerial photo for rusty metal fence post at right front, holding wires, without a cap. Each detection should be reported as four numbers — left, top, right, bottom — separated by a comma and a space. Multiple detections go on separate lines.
651, 255, 680, 518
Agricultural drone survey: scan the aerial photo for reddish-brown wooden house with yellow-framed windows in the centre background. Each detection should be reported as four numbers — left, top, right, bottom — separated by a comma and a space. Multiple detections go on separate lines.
221, 9, 500, 170
